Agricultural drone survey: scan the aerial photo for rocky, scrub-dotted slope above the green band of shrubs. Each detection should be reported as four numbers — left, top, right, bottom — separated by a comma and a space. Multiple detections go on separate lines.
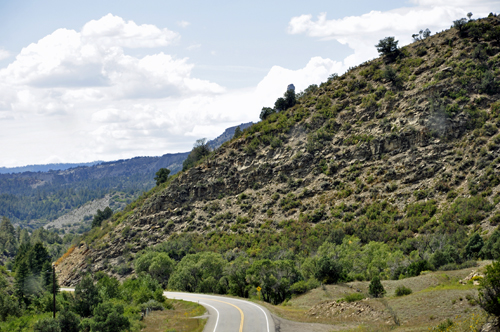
58, 15, 500, 285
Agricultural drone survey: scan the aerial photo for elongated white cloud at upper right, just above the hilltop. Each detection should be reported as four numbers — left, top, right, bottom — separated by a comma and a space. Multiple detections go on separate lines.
288, 0, 499, 67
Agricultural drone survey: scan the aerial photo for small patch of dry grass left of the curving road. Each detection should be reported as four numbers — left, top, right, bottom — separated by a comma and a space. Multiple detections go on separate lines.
141, 300, 207, 332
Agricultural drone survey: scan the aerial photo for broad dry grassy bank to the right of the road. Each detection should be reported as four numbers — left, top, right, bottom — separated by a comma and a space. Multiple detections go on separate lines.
270, 261, 489, 332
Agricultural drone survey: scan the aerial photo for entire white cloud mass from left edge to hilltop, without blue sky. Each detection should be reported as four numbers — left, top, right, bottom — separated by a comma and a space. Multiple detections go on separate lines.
8, 0, 498, 166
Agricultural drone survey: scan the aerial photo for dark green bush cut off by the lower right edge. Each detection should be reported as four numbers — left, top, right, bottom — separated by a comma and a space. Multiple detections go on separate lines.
479, 261, 500, 317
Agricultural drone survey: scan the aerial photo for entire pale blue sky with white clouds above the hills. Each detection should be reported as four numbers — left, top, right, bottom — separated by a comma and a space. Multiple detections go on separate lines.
0, 0, 500, 167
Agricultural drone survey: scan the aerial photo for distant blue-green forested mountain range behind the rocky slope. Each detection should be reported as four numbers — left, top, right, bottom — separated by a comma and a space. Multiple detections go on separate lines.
0, 122, 252, 228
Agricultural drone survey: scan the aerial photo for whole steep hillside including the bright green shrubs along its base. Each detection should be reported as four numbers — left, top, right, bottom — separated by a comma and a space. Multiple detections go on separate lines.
54, 15, 500, 326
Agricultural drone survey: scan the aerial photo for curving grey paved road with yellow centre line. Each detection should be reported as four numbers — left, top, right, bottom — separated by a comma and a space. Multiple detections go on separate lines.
163, 292, 275, 332
